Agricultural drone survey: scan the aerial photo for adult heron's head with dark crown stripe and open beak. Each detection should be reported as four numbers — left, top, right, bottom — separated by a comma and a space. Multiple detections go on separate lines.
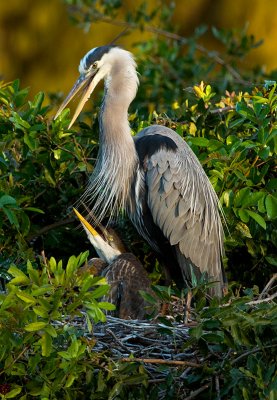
55, 46, 137, 128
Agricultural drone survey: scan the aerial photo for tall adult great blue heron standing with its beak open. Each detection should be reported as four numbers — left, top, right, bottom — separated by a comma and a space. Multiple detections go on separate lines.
55, 46, 225, 296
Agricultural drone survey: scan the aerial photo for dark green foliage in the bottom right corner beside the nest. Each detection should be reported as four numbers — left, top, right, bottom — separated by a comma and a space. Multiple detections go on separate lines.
185, 287, 277, 399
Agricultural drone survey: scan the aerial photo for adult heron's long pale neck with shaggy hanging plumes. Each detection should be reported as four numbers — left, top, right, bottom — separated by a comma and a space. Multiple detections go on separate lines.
81, 52, 138, 220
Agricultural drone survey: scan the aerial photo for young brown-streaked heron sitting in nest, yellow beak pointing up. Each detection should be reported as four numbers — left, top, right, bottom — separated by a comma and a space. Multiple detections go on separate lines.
74, 209, 155, 319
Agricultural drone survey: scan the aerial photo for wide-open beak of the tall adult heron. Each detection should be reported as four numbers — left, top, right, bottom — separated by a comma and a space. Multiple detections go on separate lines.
54, 71, 98, 128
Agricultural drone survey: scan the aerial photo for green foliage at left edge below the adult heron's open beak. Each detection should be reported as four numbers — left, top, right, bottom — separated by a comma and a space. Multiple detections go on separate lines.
0, 81, 96, 268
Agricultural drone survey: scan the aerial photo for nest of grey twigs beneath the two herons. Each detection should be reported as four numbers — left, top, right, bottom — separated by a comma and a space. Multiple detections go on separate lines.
64, 315, 203, 399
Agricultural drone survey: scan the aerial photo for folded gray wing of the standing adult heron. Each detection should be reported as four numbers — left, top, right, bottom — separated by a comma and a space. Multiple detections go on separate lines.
136, 126, 223, 295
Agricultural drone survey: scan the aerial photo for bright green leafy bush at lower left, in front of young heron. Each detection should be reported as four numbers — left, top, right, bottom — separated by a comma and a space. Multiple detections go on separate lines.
0, 253, 117, 399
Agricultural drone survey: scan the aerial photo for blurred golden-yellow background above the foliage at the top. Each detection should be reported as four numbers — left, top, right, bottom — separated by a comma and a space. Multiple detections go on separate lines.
0, 0, 277, 95
